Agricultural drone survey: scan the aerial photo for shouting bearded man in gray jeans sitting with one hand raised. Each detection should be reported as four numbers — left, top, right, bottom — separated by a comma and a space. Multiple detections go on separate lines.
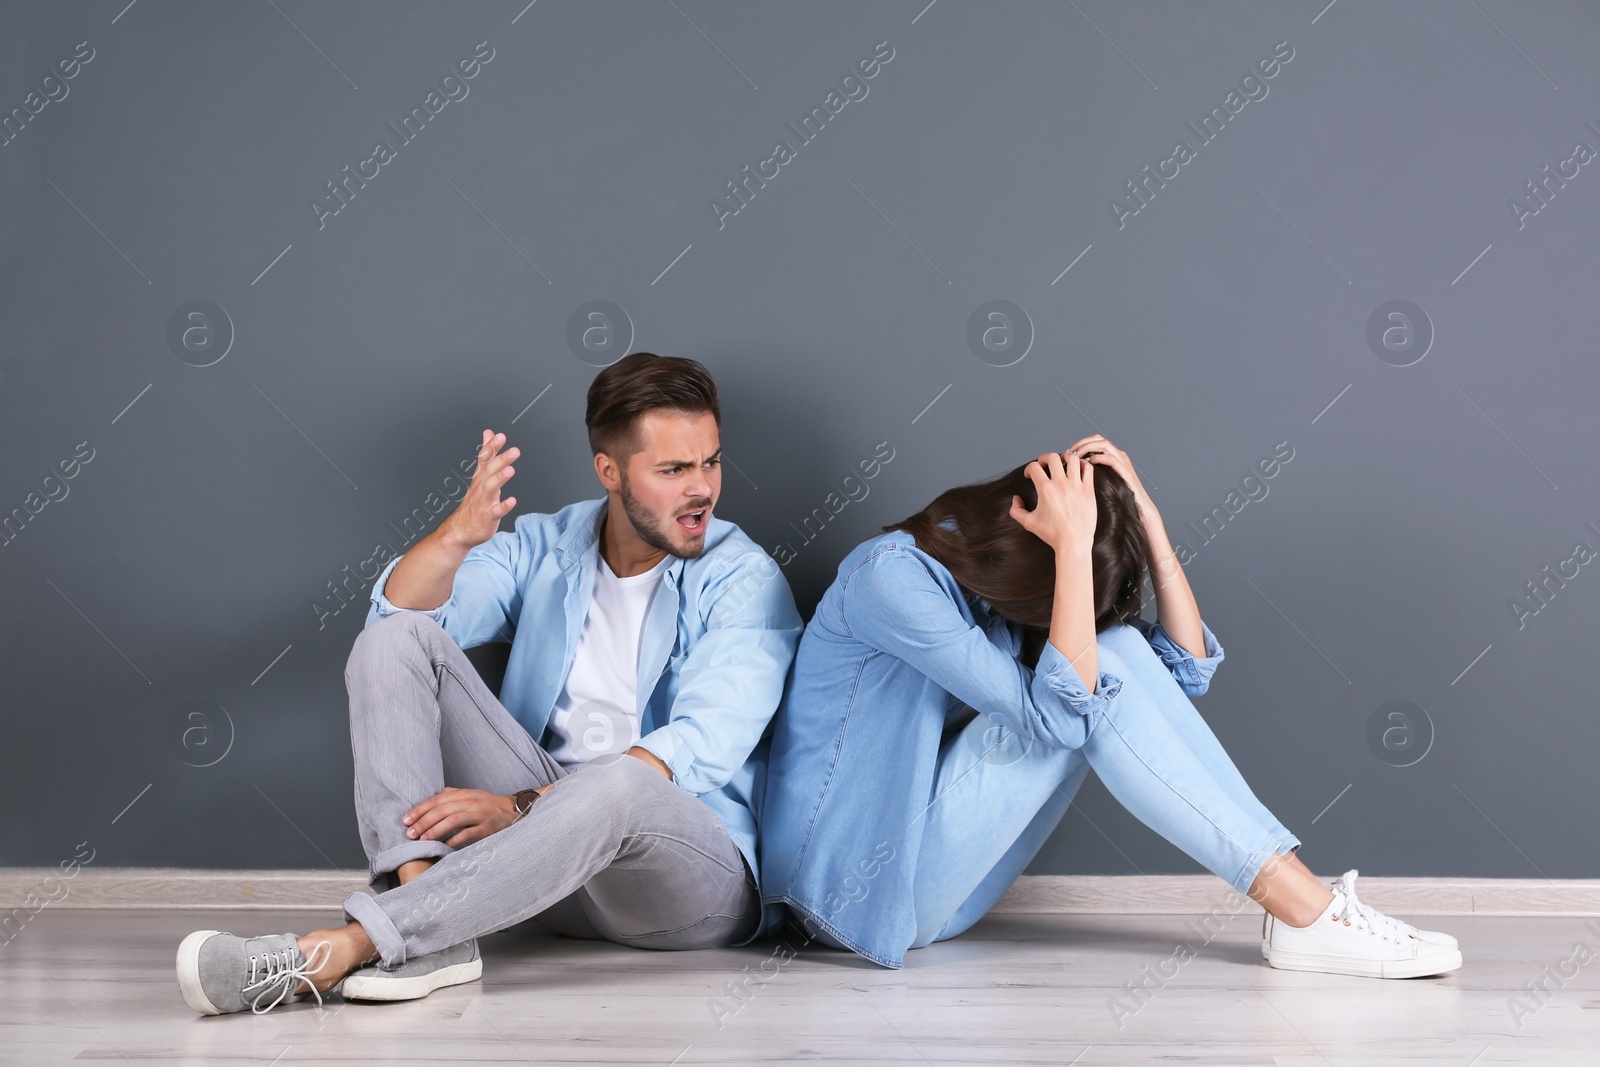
178, 352, 802, 1014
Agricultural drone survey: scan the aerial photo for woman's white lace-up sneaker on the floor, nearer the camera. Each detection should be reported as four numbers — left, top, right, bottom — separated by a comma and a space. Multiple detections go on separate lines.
1262, 870, 1461, 977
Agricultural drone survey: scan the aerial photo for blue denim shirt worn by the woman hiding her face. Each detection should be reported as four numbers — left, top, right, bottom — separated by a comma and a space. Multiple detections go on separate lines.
762, 531, 1222, 968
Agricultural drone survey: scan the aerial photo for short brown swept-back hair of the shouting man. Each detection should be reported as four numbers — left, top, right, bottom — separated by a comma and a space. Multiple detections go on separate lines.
584, 352, 722, 462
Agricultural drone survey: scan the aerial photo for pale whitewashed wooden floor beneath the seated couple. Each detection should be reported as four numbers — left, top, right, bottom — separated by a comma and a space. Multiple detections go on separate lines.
0, 909, 1600, 1067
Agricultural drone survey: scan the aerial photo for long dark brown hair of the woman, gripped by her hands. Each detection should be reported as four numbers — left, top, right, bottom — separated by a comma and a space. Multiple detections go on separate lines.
883, 461, 1149, 667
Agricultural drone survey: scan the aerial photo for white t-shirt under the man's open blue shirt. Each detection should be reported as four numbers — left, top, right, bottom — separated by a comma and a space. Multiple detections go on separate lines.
546, 555, 672, 768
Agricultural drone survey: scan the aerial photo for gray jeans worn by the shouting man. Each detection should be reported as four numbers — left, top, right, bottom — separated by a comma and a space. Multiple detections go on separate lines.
344, 611, 760, 968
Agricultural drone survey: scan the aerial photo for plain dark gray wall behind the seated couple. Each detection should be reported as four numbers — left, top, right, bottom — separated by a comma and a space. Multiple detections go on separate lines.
0, 0, 1600, 878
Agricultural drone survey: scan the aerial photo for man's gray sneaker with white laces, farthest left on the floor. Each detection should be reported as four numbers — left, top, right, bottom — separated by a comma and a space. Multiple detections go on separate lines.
178, 929, 333, 1016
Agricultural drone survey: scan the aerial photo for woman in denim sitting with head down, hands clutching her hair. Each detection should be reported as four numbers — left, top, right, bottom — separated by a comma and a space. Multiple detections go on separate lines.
762, 435, 1461, 977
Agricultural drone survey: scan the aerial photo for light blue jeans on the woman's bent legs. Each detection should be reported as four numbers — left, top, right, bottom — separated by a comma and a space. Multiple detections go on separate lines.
912, 625, 1301, 947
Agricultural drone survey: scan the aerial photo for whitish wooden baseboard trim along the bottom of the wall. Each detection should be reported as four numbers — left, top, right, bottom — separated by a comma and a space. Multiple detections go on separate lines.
0, 867, 1600, 921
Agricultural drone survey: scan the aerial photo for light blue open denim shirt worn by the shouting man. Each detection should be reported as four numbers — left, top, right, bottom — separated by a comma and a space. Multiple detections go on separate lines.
366, 498, 802, 902
